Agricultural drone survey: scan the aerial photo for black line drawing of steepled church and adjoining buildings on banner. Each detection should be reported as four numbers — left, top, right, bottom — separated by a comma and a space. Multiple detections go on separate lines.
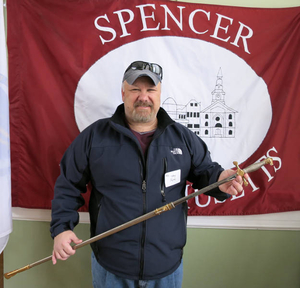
162, 68, 237, 138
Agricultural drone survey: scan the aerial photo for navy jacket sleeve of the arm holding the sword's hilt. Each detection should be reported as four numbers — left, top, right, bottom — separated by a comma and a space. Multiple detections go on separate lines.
189, 133, 231, 201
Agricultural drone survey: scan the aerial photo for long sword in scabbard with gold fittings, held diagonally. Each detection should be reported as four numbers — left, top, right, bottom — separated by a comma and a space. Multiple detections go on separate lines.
4, 158, 273, 279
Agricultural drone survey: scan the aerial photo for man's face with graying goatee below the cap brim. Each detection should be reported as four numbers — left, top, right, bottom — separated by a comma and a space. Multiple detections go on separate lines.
122, 77, 161, 124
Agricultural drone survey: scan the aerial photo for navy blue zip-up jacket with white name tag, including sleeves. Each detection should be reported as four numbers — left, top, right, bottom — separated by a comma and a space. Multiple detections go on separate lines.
51, 104, 228, 279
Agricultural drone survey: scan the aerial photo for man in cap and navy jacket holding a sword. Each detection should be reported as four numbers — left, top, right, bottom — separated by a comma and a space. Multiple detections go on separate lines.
51, 61, 247, 288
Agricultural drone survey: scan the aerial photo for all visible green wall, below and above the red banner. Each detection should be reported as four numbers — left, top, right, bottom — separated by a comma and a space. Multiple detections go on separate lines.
4, 0, 300, 288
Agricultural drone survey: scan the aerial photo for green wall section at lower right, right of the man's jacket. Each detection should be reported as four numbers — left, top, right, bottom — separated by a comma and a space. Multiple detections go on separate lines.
183, 229, 300, 288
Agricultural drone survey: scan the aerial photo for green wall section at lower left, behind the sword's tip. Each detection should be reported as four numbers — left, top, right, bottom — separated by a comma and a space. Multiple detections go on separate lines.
4, 221, 92, 288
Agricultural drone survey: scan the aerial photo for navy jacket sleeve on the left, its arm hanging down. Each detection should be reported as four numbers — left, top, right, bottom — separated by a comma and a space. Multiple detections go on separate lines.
50, 131, 92, 238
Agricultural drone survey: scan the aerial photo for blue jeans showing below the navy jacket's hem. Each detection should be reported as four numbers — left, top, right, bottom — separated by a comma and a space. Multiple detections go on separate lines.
92, 253, 183, 288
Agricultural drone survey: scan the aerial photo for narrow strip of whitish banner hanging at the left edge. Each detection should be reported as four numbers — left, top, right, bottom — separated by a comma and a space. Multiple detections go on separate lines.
0, 0, 12, 254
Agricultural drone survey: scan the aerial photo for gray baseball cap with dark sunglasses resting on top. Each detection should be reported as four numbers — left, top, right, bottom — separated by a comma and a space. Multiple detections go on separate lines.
122, 61, 162, 86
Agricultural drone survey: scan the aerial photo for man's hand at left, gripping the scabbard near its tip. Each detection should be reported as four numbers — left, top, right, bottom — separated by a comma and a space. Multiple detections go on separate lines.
52, 230, 82, 265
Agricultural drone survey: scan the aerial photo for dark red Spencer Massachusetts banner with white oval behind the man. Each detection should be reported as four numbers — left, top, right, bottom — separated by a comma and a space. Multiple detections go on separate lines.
8, 0, 300, 215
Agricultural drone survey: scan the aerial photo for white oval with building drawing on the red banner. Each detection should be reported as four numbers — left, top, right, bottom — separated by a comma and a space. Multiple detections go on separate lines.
74, 36, 272, 168
